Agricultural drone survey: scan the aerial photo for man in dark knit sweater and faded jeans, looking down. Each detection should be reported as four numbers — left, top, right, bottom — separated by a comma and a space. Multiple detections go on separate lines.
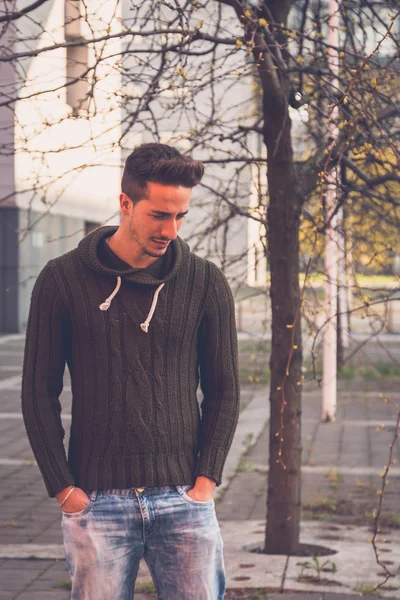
22, 144, 239, 600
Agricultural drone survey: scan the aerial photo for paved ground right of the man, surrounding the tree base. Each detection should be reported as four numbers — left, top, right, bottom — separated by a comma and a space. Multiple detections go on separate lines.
217, 382, 400, 598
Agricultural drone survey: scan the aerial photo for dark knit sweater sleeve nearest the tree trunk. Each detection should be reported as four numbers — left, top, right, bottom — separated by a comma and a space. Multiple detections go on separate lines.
196, 265, 240, 485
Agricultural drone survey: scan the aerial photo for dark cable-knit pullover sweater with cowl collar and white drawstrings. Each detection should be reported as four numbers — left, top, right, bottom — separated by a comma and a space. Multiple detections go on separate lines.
22, 227, 240, 497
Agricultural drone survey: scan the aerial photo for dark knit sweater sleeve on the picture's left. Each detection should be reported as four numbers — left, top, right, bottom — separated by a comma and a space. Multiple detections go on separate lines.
21, 261, 74, 497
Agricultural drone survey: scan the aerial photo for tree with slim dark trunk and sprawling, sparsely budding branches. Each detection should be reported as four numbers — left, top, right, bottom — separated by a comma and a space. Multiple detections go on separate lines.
0, 0, 400, 554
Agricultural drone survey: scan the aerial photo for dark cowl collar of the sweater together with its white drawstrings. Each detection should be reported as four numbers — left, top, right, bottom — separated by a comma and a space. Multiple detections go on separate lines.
78, 226, 190, 333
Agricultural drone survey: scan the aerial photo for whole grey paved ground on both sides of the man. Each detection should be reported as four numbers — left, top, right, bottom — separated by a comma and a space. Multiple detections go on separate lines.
0, 335, 400, 600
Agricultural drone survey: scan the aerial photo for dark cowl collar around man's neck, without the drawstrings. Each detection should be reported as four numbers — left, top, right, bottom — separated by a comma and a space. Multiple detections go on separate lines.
78, 226, 190, 286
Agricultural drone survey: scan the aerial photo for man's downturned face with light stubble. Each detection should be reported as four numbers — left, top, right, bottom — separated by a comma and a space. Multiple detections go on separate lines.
121, 182, 192, 258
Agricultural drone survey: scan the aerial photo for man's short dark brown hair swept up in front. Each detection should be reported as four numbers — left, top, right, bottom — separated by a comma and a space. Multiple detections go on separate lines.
121, 143, 204, 204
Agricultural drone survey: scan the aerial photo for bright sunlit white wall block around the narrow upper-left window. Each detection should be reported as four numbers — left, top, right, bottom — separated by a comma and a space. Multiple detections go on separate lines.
15, 0, 121, 221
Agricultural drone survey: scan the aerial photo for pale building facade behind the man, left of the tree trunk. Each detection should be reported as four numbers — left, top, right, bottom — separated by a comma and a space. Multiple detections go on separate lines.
0, 0, 266, 333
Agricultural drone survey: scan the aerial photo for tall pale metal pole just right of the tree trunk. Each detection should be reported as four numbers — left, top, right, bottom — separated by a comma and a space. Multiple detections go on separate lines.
322, 0, 339, 421
